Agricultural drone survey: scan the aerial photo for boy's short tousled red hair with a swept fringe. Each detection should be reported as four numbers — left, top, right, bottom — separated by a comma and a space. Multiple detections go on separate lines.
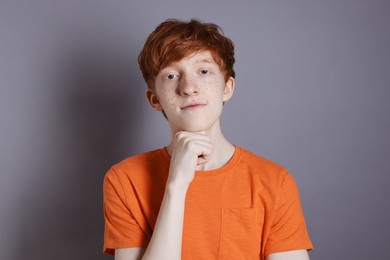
138, 19, 235, 89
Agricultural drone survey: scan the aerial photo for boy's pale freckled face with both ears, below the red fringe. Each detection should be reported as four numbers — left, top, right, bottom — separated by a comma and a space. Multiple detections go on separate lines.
146, 51, 234, 132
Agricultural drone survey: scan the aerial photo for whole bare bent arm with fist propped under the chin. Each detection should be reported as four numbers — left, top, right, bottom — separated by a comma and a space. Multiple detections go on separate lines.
115, 132, 212, 260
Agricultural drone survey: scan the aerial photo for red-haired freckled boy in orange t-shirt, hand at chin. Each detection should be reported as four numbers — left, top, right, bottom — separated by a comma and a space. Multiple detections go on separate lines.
104, 19, 312, 260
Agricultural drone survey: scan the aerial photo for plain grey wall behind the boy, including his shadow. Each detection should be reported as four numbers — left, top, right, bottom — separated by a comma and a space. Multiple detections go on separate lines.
0, 0, 390, 260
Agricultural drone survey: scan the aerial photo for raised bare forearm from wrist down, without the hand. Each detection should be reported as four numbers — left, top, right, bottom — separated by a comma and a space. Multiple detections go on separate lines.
142, 183, 188, 260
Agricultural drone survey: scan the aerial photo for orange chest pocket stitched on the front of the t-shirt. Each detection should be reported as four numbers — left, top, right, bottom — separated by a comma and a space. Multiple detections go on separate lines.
218, 208, 263, 260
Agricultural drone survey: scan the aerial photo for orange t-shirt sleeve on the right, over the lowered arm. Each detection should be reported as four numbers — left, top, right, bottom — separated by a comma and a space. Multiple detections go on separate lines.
265, 169, 313, 255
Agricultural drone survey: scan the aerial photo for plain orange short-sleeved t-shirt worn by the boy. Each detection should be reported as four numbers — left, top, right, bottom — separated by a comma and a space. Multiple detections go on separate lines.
103, 147, 312, 260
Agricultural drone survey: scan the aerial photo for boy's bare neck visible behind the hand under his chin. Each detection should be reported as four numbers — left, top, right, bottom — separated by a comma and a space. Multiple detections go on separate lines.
167, 123, 235, 171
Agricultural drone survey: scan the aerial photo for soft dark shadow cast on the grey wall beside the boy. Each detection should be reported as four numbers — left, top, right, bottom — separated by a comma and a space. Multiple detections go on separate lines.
16, 42, 144, 260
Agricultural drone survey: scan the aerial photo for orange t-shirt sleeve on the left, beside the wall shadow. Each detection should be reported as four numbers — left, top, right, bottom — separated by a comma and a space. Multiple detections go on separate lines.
103, 168, 148, 255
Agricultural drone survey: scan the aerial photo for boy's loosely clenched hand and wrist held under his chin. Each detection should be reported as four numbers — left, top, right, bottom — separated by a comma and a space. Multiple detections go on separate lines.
168, 131, 213, 186
